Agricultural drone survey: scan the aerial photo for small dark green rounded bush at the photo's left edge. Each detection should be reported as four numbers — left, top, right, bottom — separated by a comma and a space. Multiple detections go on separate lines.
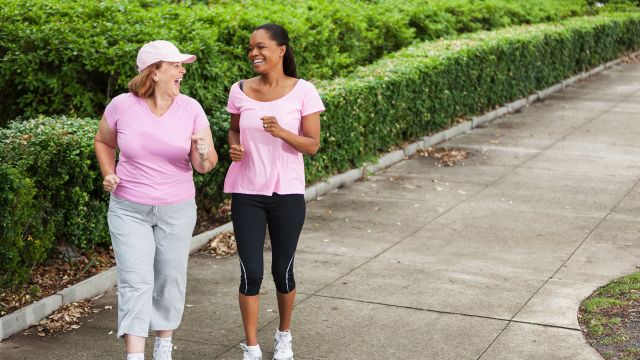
0, 164, 53, 288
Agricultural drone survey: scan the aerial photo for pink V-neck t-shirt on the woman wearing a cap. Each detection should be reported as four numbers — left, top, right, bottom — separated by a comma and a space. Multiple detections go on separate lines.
104, 93, 209, 205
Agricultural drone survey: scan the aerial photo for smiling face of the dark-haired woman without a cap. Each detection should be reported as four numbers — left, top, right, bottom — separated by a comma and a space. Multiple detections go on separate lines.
247, 29, 286, 74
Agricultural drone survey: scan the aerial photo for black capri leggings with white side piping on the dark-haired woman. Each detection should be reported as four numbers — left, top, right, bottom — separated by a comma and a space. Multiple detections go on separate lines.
231, 193, 306, 296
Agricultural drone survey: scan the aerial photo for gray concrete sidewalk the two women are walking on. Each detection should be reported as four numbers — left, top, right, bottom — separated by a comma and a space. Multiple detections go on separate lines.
0, 64, 640, 360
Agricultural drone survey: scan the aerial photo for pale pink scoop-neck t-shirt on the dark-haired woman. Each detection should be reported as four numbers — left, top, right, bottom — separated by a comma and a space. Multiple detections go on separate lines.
224, 79, 324, 195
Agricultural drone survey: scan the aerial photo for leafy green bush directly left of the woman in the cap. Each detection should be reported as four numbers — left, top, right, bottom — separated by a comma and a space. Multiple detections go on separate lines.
0, 116, 109, 249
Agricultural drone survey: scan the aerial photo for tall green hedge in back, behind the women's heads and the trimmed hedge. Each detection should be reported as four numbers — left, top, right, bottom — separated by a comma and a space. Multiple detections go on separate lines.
0, 0, 591, 126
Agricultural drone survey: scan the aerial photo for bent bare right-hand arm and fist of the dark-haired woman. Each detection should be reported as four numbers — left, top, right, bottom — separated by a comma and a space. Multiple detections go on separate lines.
262, 112, 320, 155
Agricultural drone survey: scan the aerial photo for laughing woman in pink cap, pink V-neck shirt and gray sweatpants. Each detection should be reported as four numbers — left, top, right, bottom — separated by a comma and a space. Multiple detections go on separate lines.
94, 40, 218, 360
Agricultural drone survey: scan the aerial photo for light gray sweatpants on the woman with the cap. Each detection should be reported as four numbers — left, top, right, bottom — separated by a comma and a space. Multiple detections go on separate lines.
107, 195, 196, 337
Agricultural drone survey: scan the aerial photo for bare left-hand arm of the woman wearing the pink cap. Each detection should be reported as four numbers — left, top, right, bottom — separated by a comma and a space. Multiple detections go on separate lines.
93, 116, 120, 192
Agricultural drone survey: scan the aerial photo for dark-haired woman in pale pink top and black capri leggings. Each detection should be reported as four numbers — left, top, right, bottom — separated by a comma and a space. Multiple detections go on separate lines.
224, 24, 324, 360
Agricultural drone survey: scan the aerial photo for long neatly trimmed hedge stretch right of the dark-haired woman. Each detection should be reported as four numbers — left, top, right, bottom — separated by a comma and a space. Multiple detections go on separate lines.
306, 14, 640, 180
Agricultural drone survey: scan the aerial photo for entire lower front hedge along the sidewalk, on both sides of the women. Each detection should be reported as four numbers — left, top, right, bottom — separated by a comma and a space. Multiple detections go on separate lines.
0, 15, 640, 288
